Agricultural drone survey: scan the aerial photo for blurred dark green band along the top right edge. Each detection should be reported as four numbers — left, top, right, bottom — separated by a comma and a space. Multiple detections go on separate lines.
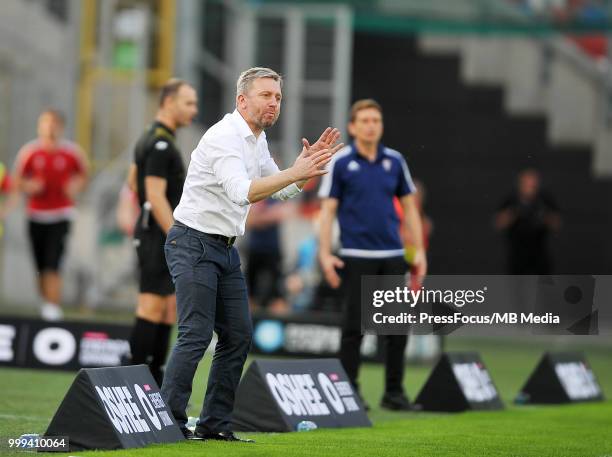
241, 0, 612, 35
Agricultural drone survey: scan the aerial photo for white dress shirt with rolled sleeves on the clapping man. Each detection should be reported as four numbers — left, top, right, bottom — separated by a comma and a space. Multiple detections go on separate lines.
174, 110, 300, 236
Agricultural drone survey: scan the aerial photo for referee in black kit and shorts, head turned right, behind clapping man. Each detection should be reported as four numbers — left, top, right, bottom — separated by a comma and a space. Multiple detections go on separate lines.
128, 79, 198, 386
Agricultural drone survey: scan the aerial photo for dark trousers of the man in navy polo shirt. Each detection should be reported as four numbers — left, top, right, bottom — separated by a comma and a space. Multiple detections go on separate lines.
340, 257, 408, 393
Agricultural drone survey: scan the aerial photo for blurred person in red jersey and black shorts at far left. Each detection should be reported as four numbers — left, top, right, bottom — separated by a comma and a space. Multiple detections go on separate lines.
15, 110, 87, 320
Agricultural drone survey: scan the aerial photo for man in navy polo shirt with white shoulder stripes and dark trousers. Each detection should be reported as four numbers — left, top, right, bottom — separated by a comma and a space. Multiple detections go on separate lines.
319, 99, 427, 410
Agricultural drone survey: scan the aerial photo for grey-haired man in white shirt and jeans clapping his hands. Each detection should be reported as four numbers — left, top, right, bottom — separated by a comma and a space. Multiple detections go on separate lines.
162, 68, 342, 441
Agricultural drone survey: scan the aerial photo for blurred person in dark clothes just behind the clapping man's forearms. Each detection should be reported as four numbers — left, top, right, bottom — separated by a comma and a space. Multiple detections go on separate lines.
246, 199, 293, 314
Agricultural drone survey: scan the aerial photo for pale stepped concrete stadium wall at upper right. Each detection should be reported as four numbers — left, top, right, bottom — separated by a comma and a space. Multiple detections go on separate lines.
420, 36, 612, 177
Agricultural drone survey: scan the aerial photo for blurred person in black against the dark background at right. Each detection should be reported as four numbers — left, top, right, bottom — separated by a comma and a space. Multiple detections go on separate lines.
495, 168, 561, 275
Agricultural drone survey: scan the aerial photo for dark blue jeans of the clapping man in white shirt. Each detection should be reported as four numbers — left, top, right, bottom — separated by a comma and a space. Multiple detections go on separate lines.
161, 225, 253, 432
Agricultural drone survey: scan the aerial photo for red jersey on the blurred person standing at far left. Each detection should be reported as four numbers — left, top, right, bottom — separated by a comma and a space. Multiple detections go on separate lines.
17, 140, 85, 222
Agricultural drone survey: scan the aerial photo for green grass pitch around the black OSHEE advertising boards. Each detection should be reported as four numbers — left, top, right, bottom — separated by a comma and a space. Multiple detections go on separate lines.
0, 337, 612, 457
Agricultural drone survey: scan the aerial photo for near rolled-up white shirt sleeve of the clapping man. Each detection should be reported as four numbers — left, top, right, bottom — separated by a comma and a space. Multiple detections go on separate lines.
204, 135, 251, 206
